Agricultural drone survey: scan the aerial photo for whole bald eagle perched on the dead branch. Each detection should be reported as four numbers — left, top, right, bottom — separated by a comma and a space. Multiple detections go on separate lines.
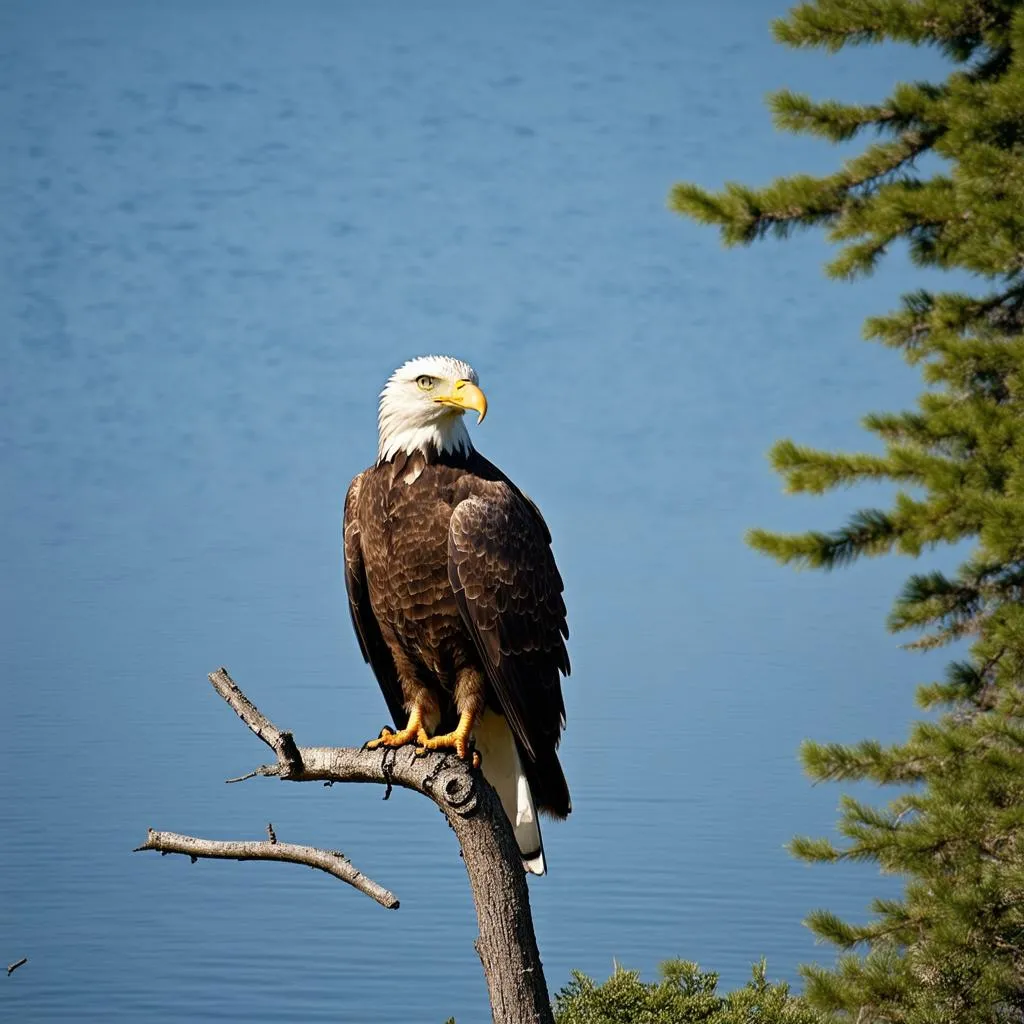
344, 356, 570, 874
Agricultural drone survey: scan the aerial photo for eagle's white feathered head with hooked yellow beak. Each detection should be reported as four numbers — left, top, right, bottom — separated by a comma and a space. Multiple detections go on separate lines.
377, 355, 487, 463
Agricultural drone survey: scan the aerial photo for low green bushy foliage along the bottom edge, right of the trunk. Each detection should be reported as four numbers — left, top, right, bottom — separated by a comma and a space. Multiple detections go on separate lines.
555, 961, 826, 1024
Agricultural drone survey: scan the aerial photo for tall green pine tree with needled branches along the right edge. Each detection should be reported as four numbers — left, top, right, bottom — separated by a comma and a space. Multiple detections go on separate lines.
672, 0, 1024, 1024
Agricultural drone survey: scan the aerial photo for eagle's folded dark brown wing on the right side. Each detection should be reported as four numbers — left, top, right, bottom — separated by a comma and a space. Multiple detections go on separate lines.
449, 481, 570, 817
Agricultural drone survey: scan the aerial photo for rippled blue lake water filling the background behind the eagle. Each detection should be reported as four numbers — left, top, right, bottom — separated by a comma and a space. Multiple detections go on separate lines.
0, 0, 954, 1024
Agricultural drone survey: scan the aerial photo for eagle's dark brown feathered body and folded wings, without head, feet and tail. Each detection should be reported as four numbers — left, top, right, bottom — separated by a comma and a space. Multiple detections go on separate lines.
345, 449, 570, 823
